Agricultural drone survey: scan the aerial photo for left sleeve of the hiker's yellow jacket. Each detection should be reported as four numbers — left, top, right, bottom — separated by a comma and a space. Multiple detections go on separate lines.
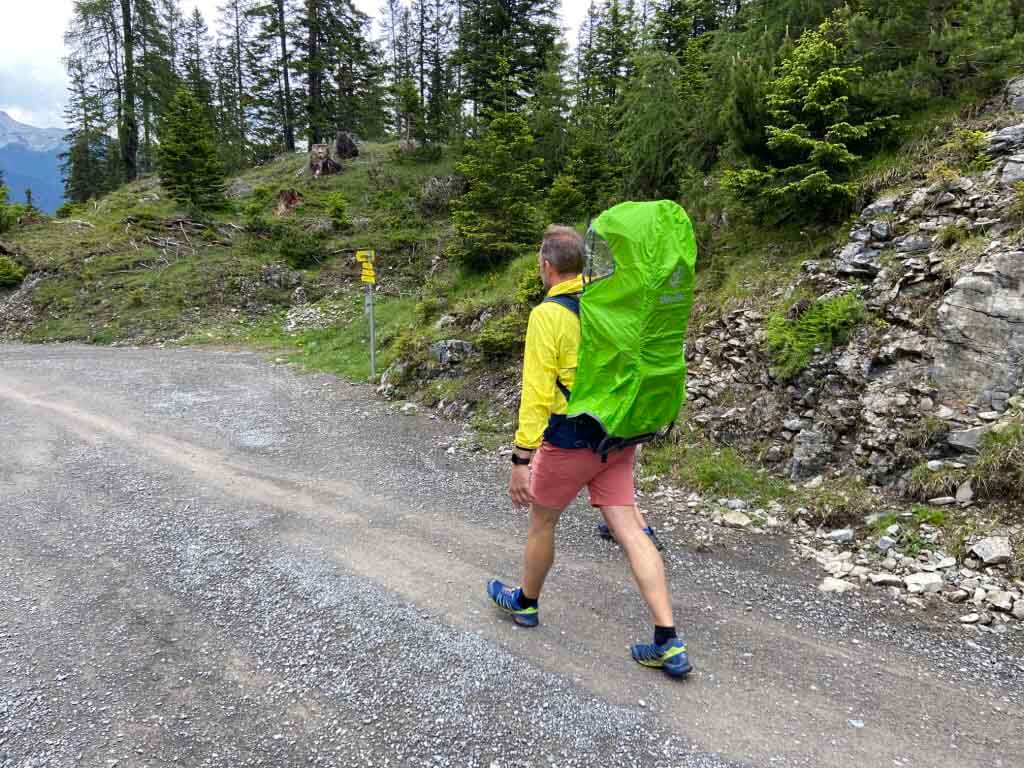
515, 304, 564, 450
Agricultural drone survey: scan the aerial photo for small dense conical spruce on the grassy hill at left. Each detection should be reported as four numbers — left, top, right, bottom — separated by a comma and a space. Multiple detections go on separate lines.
157, 88, 224, 211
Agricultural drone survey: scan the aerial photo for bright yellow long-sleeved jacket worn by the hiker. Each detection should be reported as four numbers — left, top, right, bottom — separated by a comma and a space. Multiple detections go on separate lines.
515, 275, 583, 450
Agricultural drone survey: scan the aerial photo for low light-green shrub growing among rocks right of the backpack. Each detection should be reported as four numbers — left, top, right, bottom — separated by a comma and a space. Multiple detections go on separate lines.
765, 291, 864, 380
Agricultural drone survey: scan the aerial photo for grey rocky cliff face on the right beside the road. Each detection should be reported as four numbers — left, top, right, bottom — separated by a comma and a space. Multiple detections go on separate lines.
688, 79, 1024, 499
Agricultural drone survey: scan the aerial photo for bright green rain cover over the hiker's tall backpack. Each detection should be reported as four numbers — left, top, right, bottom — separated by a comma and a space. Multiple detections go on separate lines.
567, 200, 697, 439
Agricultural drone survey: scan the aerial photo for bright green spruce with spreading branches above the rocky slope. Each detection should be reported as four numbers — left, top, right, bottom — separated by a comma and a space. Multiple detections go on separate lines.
723, 18, 895, 221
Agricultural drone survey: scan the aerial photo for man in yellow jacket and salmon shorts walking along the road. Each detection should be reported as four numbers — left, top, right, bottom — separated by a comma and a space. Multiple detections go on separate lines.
487, 226, 692, 677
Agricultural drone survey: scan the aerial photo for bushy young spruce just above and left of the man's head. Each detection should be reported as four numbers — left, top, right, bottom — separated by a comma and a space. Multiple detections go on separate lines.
452, 113, 543, 270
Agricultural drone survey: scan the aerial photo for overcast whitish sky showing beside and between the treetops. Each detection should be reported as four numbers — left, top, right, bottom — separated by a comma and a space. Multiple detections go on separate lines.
0, 0, 590, 128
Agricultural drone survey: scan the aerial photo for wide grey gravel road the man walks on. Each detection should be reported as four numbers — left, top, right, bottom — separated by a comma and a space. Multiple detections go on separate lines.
0, 345, 1024, 768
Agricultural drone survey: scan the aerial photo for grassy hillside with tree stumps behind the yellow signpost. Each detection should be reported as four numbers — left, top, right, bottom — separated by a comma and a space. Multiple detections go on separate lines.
8, 144, 452, 348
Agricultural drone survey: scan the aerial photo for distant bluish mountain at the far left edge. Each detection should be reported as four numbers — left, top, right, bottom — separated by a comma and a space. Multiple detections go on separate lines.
0, 112, 65, 213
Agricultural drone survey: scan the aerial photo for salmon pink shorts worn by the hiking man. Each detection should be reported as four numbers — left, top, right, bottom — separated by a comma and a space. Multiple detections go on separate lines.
529, 442, 636, 510
